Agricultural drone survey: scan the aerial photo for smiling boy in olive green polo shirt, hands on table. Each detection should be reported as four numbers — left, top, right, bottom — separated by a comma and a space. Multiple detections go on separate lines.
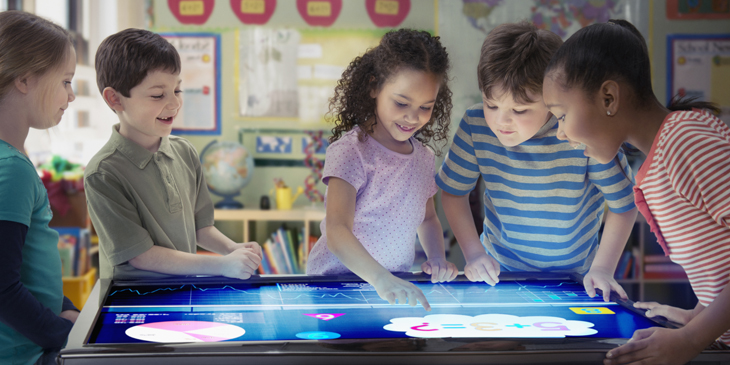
84, 29, 261, 280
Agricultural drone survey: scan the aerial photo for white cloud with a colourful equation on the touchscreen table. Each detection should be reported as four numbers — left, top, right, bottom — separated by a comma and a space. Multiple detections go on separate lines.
383, 314, 598, 338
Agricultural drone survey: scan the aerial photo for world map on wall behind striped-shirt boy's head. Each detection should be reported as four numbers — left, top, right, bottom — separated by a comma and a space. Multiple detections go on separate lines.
462, 0, 622, 38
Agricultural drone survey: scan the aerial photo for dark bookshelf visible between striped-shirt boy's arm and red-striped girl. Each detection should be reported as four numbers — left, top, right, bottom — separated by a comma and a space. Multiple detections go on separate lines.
616, 214, 697, 309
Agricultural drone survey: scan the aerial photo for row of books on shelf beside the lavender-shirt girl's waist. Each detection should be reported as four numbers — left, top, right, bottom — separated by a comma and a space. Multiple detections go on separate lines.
259, 227, 317, 274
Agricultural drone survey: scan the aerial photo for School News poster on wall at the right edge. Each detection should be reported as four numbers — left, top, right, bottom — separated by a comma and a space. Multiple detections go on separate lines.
667, 34, 730, 125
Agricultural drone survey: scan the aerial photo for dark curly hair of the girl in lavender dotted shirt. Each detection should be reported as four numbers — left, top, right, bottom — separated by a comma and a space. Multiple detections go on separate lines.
326, 29, 451, 155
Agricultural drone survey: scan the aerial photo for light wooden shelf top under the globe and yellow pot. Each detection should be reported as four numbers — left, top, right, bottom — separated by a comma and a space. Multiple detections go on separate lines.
213, 208, 325, 242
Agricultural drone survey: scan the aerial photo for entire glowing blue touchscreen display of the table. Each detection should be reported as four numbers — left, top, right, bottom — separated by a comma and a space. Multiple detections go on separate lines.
86, 279, 657, 345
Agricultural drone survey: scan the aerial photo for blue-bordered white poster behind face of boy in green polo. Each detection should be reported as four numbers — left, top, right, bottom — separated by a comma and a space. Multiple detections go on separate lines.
160, 33, 221, 135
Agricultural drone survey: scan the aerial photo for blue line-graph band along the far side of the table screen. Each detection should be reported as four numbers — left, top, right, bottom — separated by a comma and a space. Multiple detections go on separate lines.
105, 282, 602, 307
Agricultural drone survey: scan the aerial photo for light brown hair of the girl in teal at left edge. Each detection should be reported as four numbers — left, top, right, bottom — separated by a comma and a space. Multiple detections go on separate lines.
0, 10, 73, 99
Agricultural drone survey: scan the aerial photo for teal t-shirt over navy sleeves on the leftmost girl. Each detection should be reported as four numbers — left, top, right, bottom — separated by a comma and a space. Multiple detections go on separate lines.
0, 140, 63, 364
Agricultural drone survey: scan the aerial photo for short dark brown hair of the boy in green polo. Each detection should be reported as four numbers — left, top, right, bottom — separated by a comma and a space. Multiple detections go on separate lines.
95, 28, 181, 98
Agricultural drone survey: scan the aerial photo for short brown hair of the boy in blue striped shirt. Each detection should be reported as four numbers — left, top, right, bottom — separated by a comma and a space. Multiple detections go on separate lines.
477, 21, 563, 103
